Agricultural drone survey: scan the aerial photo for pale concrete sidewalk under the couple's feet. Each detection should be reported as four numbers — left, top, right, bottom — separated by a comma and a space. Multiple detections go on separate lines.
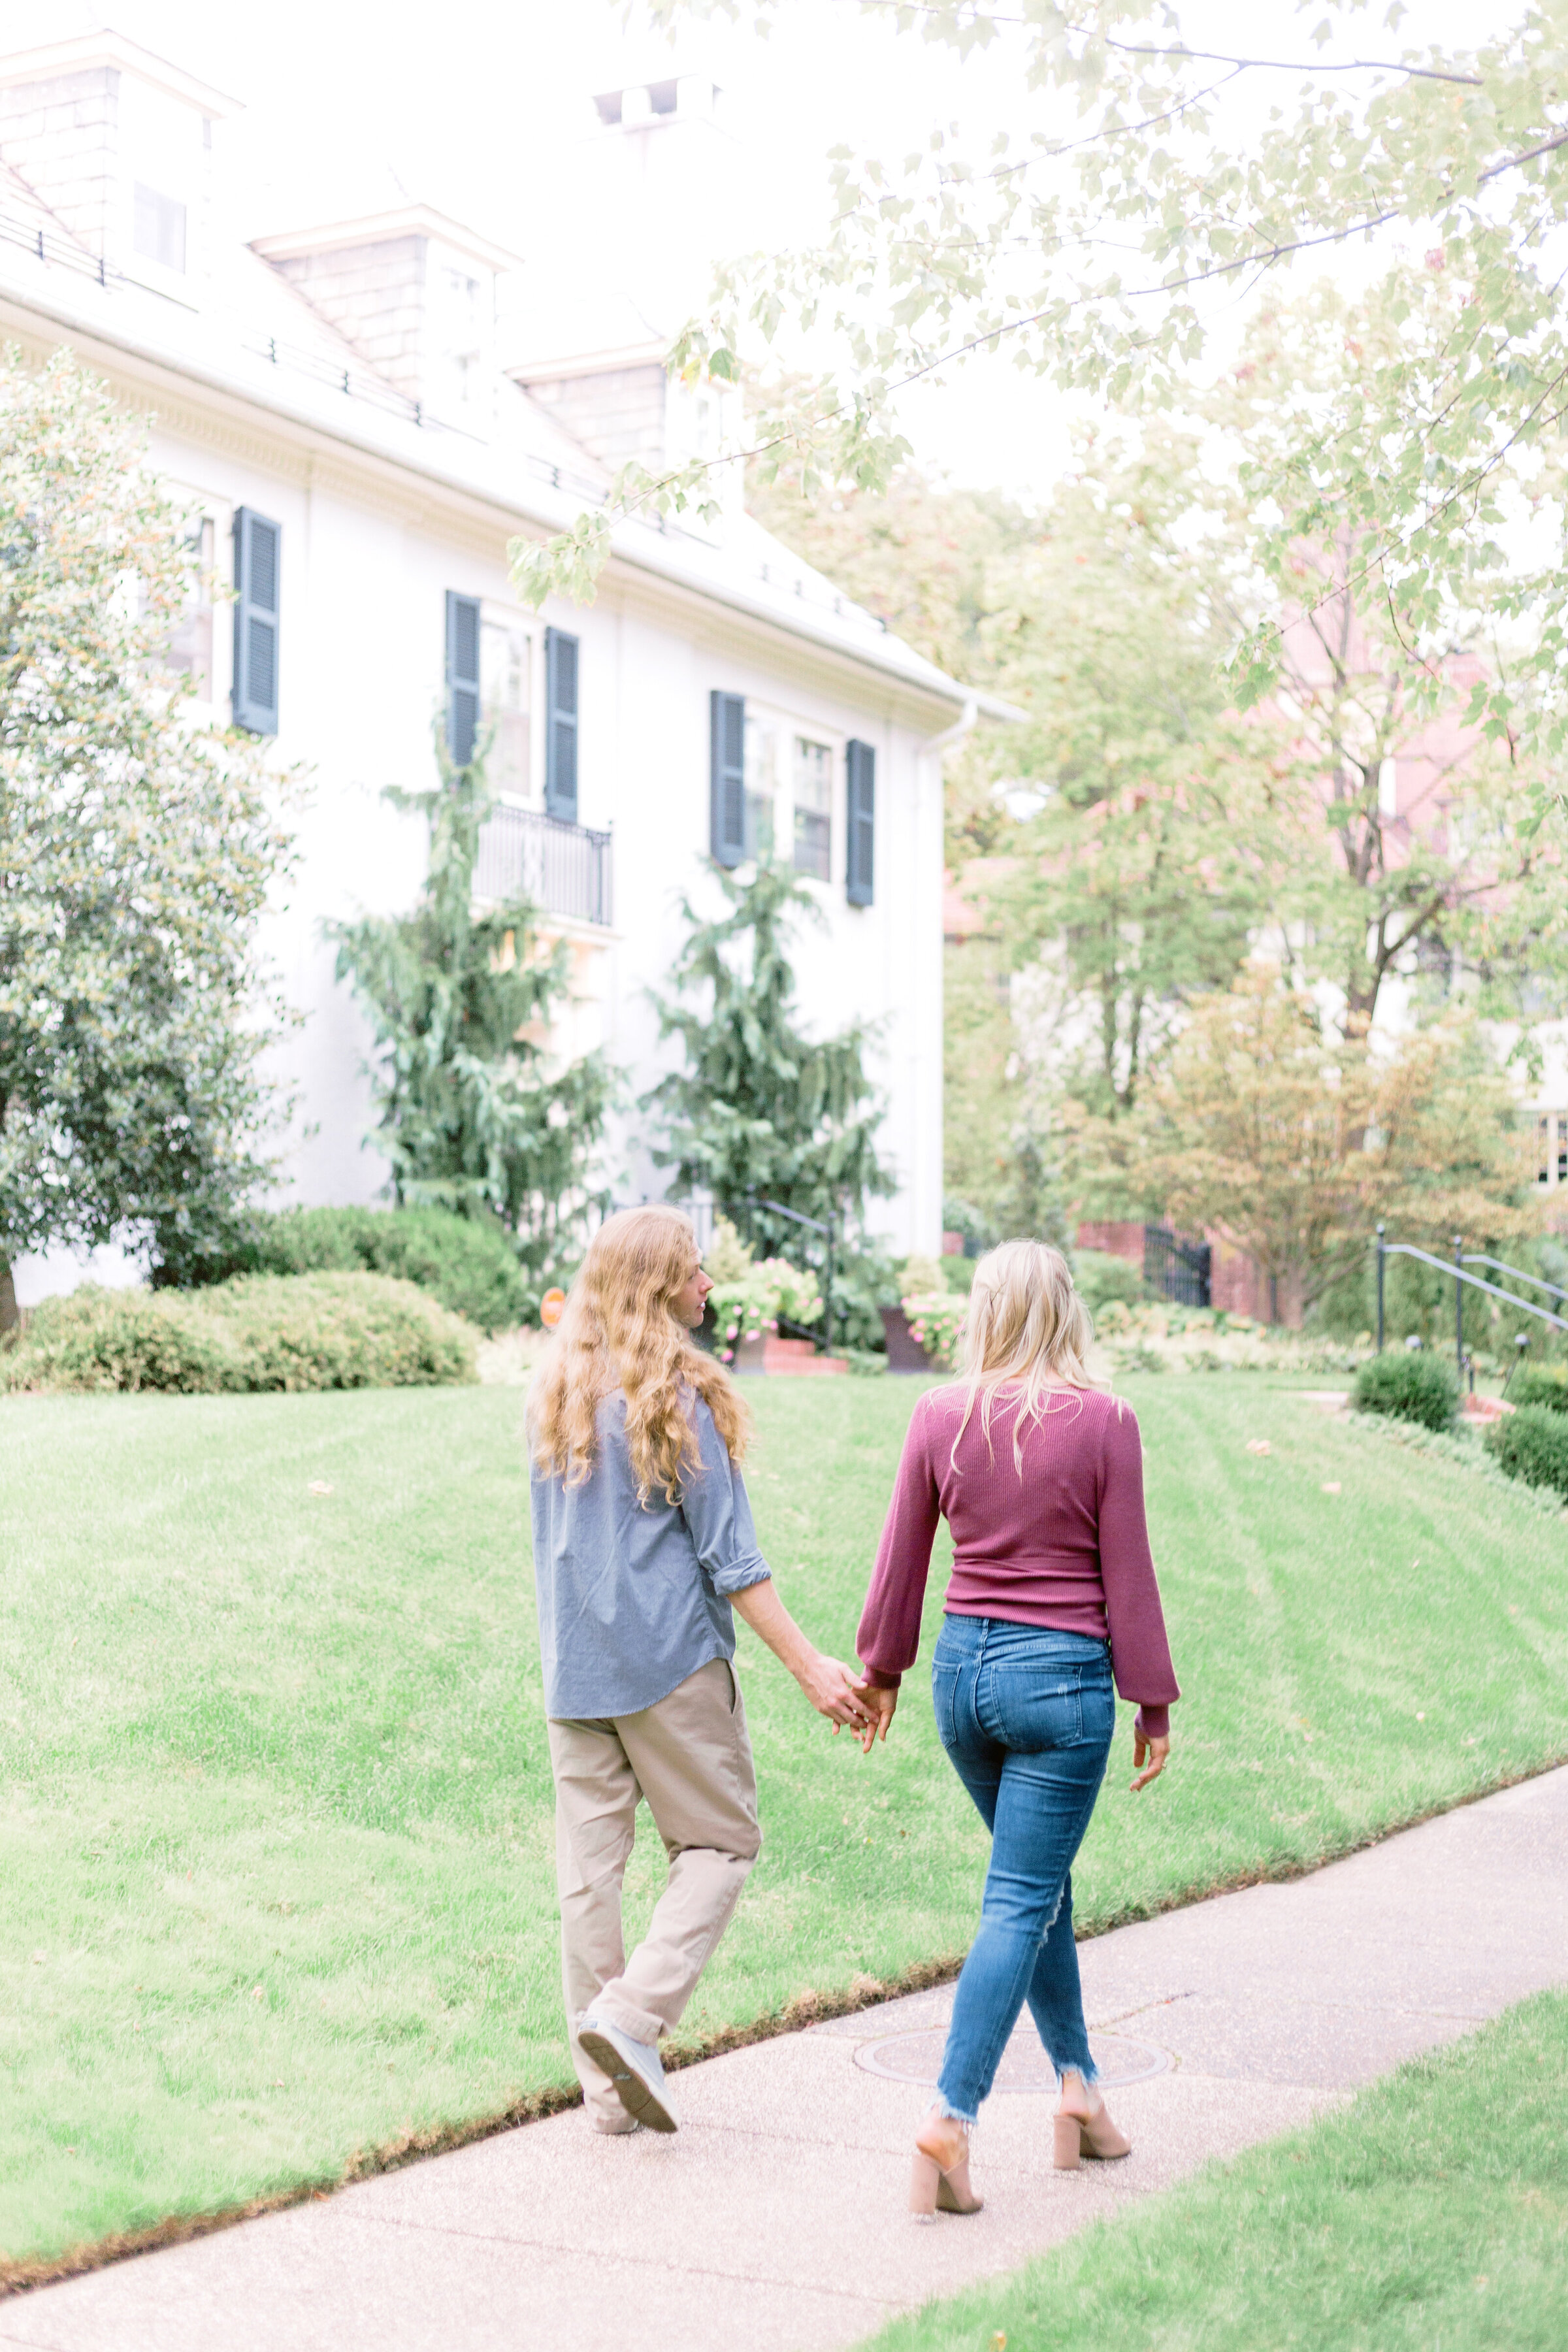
0, 1769, 1568, 2352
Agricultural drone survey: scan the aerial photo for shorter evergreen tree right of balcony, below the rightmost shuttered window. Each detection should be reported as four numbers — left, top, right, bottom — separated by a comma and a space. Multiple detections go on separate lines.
644, 866, 896, 1249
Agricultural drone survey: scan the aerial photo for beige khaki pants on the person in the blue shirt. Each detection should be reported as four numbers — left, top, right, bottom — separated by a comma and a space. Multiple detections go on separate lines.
550, 1658, 762, 2119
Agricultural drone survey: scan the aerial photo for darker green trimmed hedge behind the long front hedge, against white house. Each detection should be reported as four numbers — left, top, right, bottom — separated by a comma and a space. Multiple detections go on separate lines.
252, 1209, 541, 1331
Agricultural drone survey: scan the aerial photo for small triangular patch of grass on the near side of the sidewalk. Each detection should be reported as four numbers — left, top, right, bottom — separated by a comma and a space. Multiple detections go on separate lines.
860, 1992, 1568, 2352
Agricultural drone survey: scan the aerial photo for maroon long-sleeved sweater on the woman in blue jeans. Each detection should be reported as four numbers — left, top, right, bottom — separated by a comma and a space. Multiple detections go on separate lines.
856, 1388, 1180, 1738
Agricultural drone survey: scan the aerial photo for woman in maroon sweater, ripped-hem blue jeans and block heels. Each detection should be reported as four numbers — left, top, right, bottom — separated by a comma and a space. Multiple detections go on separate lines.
856, 1242, 1180, 2220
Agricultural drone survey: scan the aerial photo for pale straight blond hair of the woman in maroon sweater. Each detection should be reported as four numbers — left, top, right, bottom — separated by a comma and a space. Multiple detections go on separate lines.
950, 1242, 1096, 1479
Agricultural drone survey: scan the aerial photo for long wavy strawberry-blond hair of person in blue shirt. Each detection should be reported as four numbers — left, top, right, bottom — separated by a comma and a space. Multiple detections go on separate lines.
529, 1207, 752, 1503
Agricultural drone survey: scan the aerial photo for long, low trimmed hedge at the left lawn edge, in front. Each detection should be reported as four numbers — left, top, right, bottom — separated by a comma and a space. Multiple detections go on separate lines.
0, 1275, 477, 1397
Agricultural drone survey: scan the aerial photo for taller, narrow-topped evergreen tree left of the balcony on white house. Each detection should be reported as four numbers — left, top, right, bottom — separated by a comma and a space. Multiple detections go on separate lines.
331, 738, 613, 1275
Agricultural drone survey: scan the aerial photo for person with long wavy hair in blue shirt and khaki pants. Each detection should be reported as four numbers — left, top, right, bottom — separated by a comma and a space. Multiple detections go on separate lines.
529, 1207, 870, 2131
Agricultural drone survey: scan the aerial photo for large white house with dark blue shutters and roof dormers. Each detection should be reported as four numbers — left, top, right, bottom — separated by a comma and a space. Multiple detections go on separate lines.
0, 33, 983, 1298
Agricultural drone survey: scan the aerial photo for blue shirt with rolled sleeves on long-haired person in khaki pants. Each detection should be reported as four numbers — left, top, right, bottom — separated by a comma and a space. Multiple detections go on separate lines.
531, 1392, 771, 1722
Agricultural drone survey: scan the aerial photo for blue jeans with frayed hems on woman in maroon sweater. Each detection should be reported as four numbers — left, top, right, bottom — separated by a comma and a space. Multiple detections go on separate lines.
931, 1616, 1117, 2124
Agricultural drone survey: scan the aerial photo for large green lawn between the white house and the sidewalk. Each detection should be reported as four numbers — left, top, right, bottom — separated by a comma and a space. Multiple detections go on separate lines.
0, 1376, 1568, 2261
